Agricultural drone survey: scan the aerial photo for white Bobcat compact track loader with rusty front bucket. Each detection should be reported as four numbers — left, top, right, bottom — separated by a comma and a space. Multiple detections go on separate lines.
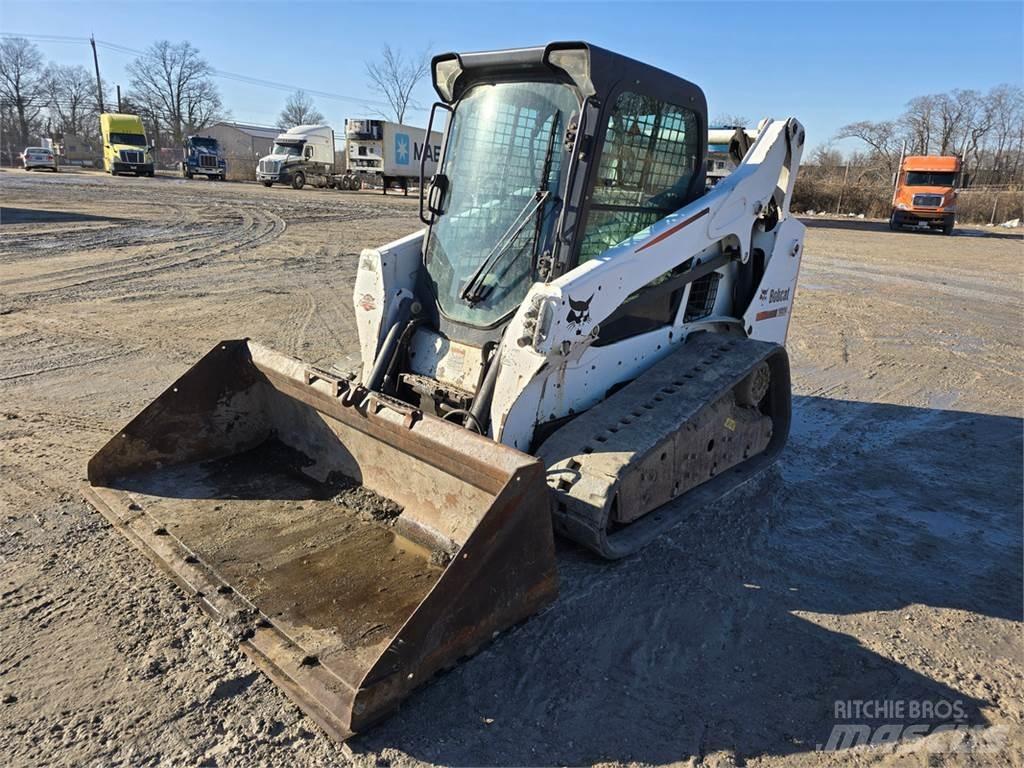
86, 43, 804, 739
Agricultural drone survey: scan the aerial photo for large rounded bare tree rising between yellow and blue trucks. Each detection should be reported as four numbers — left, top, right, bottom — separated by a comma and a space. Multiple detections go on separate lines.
128, 40, 221, 143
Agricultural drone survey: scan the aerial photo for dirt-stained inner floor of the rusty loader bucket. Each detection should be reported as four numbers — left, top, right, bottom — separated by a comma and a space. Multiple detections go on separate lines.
119, 438, 443, 670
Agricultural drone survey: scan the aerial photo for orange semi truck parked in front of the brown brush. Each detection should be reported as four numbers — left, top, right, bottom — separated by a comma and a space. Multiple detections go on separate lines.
889, 155, 961, 234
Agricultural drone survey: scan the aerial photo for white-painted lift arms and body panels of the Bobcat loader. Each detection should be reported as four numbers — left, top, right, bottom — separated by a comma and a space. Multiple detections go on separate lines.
354, 119, 805, 450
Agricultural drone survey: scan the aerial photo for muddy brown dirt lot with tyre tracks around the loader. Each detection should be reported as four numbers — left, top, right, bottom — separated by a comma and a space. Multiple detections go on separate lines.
0, 171, 1024, 766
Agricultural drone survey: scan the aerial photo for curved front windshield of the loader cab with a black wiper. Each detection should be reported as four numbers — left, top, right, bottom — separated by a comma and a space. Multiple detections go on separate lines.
424, 82, 580, 327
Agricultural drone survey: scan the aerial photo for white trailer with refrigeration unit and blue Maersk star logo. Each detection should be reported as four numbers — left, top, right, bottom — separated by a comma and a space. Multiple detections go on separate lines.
345, 119, 441, 194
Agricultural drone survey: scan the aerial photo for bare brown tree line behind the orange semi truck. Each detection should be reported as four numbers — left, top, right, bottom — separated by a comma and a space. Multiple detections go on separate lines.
823, 84, 1024, 185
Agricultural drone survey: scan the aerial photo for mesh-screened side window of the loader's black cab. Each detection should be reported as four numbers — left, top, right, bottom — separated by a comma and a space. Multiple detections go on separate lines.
580, 91, 700, 263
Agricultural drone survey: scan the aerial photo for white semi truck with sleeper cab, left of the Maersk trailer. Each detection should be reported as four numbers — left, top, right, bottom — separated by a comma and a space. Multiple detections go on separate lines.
256, 125, 335, 189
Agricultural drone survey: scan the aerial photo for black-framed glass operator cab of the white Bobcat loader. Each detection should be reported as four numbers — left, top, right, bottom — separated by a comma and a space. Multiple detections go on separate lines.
387, 42, 708, 428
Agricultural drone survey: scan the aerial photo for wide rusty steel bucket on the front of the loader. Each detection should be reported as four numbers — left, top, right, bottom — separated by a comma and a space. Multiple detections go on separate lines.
85, 340, 557, 739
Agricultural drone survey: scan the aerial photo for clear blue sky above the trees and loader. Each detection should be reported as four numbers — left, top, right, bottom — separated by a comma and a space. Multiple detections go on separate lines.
0, 0, 1024, 153
